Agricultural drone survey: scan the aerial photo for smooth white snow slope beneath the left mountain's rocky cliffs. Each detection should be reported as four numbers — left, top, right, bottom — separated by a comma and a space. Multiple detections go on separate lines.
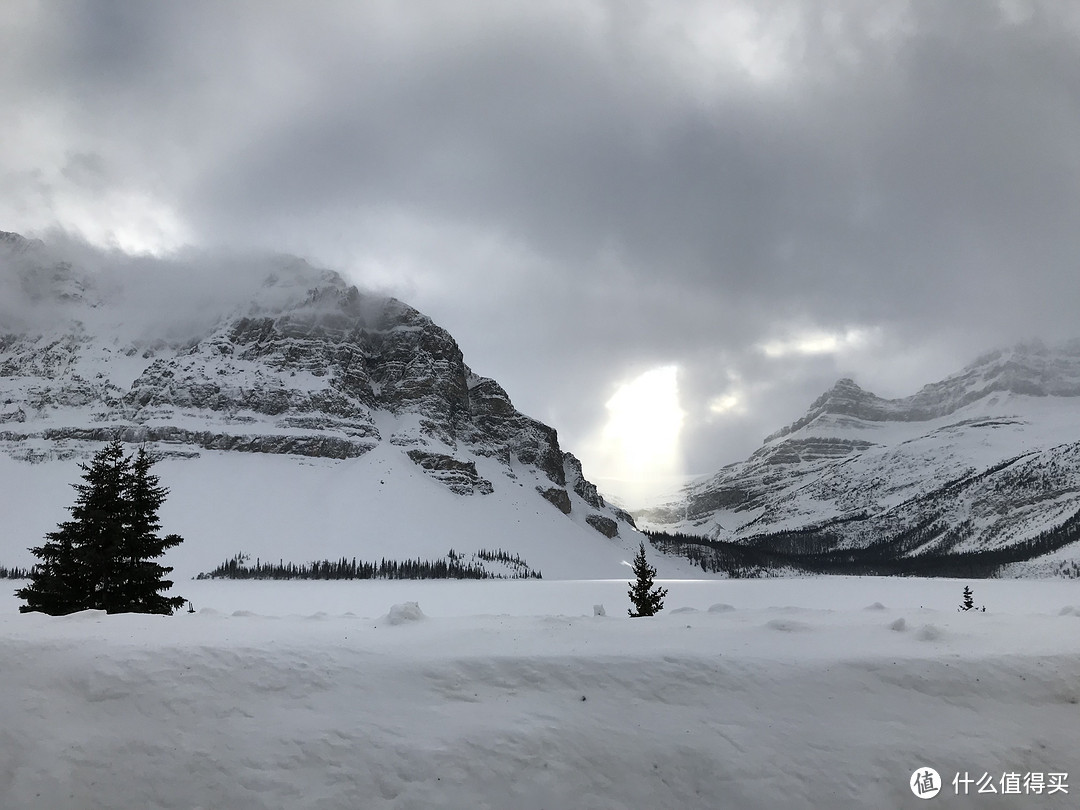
0, 444, 673, 583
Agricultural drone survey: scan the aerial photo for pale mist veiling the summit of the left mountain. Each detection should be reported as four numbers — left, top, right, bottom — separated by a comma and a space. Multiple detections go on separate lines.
0, 232, 401, 342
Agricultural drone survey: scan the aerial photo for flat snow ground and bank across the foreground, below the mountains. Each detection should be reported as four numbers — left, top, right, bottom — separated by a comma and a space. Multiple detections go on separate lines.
0, 578, 1080, 810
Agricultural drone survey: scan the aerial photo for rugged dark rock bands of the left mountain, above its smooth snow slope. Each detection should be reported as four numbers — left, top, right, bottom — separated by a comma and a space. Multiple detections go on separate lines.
0, 233, 632, 542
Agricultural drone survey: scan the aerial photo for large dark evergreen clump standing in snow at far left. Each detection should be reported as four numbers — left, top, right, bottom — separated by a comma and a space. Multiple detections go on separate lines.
15, 440, 185, 616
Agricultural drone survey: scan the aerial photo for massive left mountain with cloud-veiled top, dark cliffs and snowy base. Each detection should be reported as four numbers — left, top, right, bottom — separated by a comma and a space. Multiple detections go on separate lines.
0, 233, 639, 577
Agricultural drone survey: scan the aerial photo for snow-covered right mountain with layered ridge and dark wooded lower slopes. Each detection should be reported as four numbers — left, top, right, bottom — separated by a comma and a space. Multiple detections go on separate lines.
637, 341, 1080, 573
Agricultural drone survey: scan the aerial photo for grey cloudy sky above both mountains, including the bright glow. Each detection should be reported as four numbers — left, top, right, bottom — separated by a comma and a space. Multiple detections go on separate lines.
0, 0, 1080, 507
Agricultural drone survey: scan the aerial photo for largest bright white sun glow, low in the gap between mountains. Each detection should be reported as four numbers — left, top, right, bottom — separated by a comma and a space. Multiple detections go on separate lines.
588, 365, 686, 502
